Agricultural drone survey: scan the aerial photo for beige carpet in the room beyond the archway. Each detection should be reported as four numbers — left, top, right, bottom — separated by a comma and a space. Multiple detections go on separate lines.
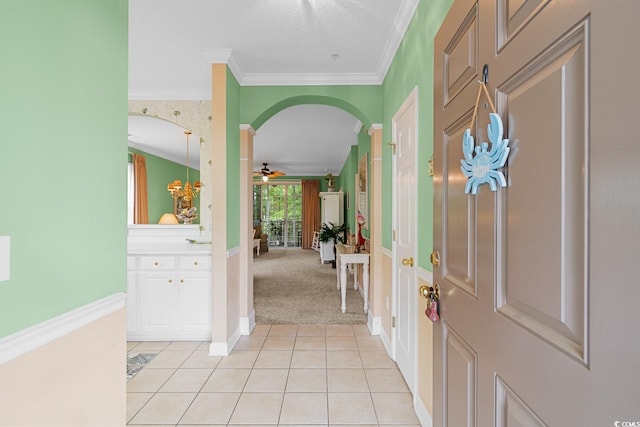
253, 248, 367, 324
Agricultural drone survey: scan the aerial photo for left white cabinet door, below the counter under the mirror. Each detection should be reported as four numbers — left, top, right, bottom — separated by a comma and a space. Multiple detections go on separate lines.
136, 273, 178, 332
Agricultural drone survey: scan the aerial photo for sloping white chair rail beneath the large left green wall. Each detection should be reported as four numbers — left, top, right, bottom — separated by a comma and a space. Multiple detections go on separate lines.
0, 292, 127, 364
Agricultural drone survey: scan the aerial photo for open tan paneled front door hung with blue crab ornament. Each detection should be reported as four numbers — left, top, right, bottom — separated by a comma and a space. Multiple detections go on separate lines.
433, 0, 640, 427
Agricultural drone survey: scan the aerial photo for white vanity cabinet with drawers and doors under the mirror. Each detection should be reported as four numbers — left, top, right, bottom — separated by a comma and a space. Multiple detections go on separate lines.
127, 254, 211, 341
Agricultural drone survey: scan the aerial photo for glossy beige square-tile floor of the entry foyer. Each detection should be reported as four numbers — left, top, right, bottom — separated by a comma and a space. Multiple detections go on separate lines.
127, 325, 420, 427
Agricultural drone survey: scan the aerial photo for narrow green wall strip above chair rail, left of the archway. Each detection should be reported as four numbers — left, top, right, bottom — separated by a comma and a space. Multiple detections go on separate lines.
228, 67, 246, 249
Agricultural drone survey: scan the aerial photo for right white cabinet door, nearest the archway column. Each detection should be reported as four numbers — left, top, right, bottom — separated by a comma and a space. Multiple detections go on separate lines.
178, 272, 211, 338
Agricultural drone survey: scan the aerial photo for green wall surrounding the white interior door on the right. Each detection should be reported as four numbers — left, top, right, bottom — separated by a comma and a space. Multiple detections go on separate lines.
382, 0, 452, 270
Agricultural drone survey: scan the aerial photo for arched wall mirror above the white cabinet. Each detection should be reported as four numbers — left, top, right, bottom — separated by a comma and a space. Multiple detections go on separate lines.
128, 115, 200, 224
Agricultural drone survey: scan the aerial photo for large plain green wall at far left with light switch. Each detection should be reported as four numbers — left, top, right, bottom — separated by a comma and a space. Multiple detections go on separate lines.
0, 0, 128, 337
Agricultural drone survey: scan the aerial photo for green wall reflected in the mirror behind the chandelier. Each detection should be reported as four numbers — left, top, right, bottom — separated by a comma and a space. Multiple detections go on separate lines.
129, 148, 201, 224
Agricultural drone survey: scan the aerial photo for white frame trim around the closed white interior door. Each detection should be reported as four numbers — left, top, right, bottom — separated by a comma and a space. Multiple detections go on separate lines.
391, 86, 419, 399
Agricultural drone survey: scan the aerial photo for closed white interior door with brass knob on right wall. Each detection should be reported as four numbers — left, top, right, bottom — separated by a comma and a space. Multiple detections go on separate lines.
392, 90, 418, 391
